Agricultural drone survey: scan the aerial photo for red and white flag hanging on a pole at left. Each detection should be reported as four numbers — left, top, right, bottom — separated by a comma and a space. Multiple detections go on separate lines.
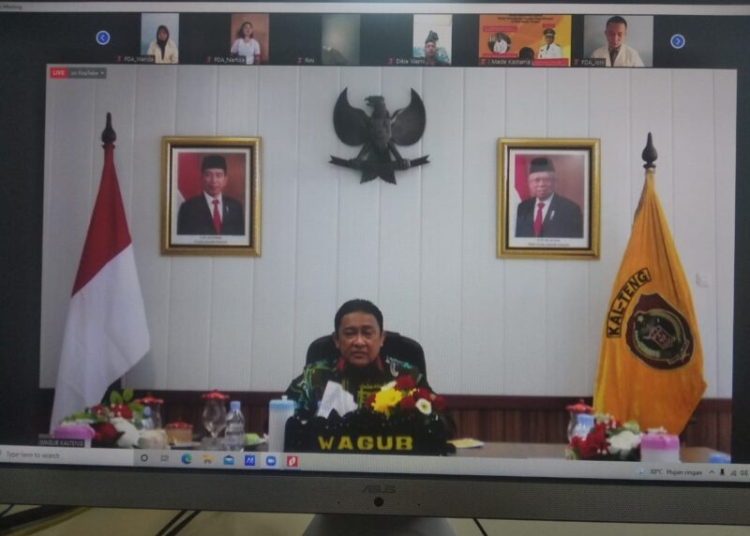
51, 130, 151, 427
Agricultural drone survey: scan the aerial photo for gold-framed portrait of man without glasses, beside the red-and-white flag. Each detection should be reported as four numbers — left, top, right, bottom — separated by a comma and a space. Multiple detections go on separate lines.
162, 137, 261, 257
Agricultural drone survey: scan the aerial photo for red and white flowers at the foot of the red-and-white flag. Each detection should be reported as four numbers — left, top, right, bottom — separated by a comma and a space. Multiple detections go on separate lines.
53, 388, 143, 447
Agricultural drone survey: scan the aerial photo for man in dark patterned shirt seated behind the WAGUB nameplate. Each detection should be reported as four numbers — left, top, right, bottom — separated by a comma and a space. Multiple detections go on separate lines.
286, 300, 432, 417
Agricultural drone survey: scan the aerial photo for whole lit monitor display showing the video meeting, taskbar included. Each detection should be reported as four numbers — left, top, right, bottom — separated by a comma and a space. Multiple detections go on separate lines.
0, 2, 750, 483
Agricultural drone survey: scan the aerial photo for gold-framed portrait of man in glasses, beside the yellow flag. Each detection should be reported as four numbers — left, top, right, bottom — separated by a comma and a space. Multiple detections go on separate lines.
497, 138, 600, 259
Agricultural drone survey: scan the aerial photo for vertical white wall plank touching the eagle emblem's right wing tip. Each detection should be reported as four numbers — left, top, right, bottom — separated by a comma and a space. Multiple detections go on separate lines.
420, 69, 465, 393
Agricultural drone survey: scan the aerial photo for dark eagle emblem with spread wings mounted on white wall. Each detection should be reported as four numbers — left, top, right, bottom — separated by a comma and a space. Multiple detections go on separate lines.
331, 89, 429, 184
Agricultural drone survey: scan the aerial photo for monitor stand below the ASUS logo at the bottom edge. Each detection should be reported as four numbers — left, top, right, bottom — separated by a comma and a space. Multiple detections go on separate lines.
302, 514, 456, 536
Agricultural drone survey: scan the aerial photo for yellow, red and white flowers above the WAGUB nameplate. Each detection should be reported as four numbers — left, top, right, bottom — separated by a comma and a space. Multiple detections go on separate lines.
365, 375, 445, 417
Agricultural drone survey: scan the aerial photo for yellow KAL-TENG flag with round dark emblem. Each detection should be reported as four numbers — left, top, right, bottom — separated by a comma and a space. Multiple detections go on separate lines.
594, 169, 706, 434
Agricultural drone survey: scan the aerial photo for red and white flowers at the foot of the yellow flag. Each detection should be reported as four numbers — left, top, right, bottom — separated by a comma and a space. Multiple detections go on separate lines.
565, 414, 641, 461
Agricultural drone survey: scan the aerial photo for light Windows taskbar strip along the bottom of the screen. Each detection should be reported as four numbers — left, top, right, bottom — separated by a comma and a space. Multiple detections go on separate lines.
0, 445, 750, 484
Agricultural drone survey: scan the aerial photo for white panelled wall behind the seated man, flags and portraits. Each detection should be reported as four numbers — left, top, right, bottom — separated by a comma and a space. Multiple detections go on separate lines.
40, 66, 736, 397
